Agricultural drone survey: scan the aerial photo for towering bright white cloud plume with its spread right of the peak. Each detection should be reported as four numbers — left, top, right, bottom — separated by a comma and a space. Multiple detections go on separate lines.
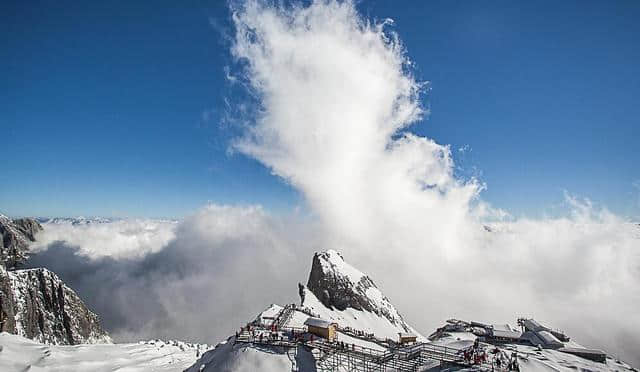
232, 1, 640, 364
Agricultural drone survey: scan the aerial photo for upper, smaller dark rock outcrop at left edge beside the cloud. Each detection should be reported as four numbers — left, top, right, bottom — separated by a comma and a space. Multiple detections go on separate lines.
0, 215, 42, 268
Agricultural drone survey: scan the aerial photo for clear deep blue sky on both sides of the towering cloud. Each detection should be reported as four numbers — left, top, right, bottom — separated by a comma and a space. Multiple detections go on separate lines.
0, 1, 640, 219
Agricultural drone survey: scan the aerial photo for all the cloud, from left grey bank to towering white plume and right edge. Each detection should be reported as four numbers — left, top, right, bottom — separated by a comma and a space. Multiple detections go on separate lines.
31, 0, 640, 364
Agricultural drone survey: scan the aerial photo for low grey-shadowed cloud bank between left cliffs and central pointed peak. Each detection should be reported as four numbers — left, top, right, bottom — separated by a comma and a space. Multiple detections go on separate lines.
28, 205, 323, 343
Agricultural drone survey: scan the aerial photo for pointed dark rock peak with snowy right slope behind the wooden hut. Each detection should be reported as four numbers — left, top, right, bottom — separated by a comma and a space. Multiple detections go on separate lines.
306, 250, 409, 331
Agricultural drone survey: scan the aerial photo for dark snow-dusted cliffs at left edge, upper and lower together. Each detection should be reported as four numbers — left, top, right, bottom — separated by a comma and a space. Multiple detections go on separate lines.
0, 215, 111, 345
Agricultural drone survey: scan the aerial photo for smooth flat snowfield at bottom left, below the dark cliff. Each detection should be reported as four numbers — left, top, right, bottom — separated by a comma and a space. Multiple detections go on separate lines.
0, 332, 207, 372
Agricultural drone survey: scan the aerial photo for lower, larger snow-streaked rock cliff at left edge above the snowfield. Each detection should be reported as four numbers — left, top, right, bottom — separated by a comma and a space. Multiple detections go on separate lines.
0, 268, 111, 345
